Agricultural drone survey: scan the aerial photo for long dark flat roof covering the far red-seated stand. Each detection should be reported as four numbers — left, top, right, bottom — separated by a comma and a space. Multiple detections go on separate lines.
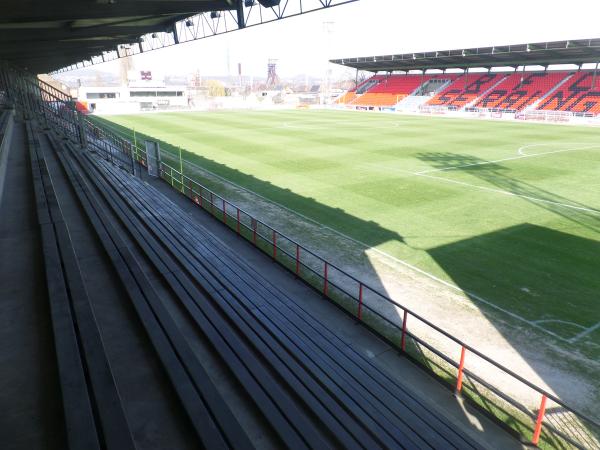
331, 39, 600, 72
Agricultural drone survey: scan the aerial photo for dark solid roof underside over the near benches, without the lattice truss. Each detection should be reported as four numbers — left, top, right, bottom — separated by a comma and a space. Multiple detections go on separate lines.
0, 0, 235, 73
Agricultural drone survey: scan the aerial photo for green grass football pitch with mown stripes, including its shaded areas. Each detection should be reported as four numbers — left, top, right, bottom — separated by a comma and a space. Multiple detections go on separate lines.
97, 111, 600, 347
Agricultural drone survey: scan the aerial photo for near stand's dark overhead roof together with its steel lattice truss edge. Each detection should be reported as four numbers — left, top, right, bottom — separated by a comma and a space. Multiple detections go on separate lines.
0, 0, 357, 73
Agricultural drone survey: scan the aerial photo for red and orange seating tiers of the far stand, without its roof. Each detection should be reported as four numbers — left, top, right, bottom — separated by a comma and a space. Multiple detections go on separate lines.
336, 70, 600, 115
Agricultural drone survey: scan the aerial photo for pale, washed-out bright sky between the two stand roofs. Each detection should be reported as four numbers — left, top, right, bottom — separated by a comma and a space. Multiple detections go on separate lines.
58, 0, 600, 81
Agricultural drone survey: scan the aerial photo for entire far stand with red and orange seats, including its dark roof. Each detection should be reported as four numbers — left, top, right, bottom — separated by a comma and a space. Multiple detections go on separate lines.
332, 40, 600, 116
